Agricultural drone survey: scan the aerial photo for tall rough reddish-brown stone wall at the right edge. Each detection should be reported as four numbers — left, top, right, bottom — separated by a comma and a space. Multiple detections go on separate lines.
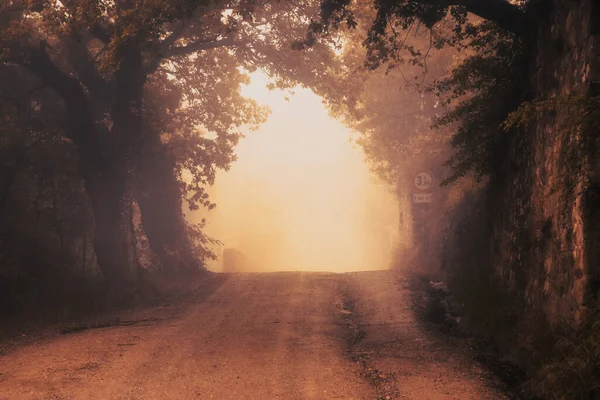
490, 0, 600, 324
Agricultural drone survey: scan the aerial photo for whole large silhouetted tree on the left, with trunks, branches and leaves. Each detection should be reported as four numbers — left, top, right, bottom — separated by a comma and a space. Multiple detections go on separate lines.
0, 0, 344, 294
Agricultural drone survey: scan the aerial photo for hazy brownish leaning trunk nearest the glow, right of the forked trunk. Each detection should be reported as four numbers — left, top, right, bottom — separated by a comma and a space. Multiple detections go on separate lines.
135, 132, 202, 272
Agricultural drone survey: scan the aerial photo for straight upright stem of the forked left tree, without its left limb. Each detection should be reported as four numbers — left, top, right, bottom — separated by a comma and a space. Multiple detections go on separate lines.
101, 43, 146, 292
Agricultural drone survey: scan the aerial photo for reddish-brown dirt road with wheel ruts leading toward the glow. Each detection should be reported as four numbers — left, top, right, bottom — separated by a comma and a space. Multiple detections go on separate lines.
0, 272, 505, 400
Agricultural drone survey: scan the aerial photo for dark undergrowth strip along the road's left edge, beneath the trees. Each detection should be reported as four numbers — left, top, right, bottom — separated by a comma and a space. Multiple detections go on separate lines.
0, 271, 227, 351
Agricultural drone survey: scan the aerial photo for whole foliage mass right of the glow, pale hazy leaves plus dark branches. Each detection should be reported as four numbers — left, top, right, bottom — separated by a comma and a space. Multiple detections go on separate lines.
314, 5, 523, 188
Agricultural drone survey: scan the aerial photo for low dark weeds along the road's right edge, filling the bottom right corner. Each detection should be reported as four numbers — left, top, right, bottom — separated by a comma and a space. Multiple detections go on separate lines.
413, 262, 600, 400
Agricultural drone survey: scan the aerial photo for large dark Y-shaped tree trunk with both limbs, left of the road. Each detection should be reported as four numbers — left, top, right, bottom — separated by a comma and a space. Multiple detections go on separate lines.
21, 50, 143, 298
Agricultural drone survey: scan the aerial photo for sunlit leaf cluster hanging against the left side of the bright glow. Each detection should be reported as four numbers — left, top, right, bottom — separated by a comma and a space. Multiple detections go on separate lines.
144, 59, 268, 210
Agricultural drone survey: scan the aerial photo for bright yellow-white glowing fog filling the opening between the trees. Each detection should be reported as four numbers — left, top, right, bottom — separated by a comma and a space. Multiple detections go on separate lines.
193, 74, 398, 272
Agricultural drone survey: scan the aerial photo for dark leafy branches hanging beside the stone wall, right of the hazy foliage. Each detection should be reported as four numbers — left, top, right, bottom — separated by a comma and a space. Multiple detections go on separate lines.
430, 24, 522, 184
